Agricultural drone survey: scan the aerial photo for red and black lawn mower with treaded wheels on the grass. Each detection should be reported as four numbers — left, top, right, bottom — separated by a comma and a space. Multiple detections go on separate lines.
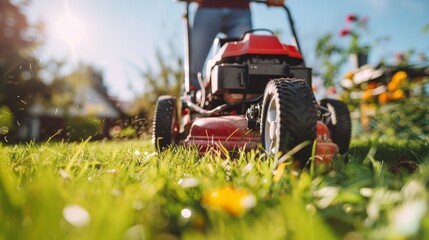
153, 0, 351, 167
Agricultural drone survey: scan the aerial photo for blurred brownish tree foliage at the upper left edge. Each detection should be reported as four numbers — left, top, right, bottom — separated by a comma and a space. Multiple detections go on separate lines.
0, 0, 45, 127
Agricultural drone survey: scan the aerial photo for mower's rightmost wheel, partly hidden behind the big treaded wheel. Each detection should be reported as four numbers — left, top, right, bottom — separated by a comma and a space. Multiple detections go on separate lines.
320, 98, 352, 154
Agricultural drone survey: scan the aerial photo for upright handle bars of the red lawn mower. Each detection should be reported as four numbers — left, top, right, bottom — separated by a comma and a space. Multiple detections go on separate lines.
174, 0, 305, 93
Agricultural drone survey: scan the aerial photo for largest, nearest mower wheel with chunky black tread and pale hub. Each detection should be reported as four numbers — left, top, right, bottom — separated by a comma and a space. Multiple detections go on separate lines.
261, 78, 317, 167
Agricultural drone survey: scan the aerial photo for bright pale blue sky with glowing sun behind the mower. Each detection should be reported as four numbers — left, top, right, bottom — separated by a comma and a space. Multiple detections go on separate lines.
25, 0, 429, 100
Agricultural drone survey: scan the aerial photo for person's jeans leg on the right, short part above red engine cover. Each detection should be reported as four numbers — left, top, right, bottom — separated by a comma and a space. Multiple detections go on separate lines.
222, 8, 252, 38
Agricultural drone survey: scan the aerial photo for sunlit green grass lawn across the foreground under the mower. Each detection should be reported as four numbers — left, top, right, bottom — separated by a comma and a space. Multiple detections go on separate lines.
0, 139, 429, 240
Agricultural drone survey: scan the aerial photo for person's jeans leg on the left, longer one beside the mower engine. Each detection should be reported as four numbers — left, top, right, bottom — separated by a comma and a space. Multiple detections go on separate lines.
190, 8, 222, 90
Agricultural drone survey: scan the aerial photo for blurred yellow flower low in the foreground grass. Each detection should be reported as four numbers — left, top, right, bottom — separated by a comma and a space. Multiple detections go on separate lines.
201, 186, 256, 216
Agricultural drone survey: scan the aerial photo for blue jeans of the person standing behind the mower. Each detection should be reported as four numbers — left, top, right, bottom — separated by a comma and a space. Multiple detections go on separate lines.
190, 8, 252, 90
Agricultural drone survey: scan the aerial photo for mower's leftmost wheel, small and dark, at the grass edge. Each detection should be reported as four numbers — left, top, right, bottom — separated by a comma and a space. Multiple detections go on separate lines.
152, 96, 177, 151
